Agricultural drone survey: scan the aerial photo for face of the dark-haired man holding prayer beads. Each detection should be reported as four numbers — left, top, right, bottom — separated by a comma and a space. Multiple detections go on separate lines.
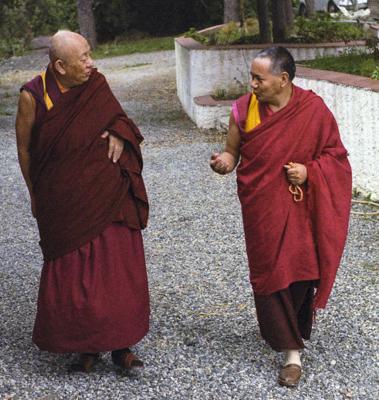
250, 58, 283, 104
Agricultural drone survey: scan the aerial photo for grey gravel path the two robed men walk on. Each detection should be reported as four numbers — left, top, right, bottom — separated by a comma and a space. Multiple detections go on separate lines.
0, 52, 379, 400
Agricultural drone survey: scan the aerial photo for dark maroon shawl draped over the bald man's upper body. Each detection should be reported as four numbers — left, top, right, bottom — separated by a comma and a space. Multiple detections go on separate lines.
30, 69, 148, 260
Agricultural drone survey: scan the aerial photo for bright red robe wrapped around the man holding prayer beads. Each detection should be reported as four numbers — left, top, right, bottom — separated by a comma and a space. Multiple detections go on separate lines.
236, 85, 352, 308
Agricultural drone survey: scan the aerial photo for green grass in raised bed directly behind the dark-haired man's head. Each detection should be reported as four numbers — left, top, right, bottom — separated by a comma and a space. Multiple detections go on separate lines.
299, 54, 379, 77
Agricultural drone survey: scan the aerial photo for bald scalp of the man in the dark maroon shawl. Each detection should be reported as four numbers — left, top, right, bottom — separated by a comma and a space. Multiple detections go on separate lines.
49, 30, 88, 63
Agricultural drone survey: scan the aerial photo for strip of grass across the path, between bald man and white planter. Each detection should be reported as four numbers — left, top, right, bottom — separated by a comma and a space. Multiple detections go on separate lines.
92, 36, 175, 59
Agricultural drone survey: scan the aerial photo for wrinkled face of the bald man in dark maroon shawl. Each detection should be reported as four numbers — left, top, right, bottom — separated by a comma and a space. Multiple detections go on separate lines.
62, 38, 93, 87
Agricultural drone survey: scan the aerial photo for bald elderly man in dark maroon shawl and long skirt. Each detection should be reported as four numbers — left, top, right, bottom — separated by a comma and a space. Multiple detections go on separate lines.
16, 31, 149, 372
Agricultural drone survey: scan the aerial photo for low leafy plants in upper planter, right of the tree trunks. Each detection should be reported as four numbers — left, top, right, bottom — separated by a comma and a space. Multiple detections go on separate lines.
289, 14, 365, 43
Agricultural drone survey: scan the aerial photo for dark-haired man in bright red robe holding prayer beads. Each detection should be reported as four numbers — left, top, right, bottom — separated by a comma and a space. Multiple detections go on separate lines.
210, 47, 351, 386
